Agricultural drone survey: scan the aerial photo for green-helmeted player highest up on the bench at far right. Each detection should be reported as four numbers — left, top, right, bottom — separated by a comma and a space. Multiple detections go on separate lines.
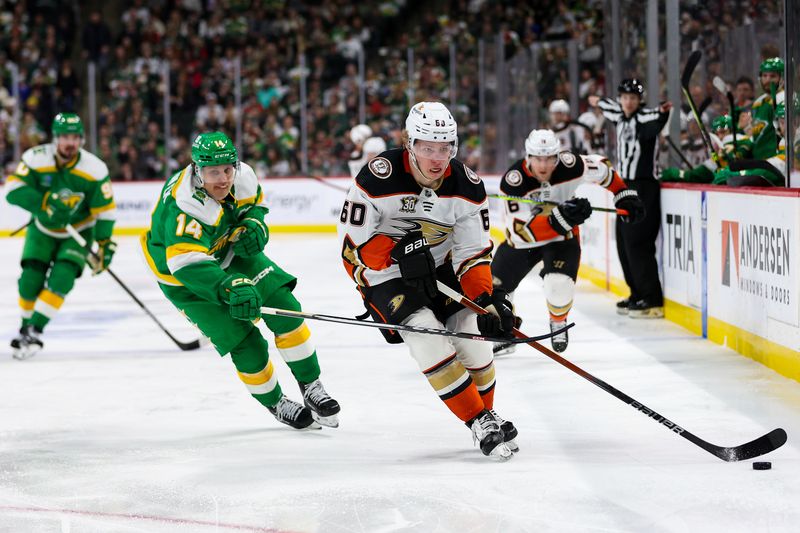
750, 57, 784, 159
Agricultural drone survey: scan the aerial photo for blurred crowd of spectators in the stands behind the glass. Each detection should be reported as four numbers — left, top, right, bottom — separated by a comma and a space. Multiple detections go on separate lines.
0, 0, 779, 180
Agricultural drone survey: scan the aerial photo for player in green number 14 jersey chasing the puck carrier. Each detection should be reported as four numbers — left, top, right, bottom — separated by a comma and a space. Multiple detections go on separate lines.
142, 132, 339, 429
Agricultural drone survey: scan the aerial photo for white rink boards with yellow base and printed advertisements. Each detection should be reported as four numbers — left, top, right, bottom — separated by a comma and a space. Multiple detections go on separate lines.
0, 176, 800, 380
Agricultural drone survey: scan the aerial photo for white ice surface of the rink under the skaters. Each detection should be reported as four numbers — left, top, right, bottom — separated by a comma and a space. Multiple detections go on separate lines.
0, 235, 800, 533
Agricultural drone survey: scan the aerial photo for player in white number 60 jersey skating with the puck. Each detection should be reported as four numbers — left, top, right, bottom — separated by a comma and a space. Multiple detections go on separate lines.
339, 102, 518, 458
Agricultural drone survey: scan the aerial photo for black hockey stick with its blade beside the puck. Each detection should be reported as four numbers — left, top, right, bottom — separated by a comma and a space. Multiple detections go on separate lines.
437, 282, 786, 462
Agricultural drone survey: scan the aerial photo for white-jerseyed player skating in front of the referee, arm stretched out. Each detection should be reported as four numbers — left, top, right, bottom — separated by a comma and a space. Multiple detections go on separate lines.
492, 130, 644, 352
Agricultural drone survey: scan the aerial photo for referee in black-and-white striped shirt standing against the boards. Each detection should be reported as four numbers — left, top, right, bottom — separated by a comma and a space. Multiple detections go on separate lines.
589, 78, 672, 318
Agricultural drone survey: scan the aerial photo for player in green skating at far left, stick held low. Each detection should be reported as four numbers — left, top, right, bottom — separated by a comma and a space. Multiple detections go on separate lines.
6, 113, 116, 359
